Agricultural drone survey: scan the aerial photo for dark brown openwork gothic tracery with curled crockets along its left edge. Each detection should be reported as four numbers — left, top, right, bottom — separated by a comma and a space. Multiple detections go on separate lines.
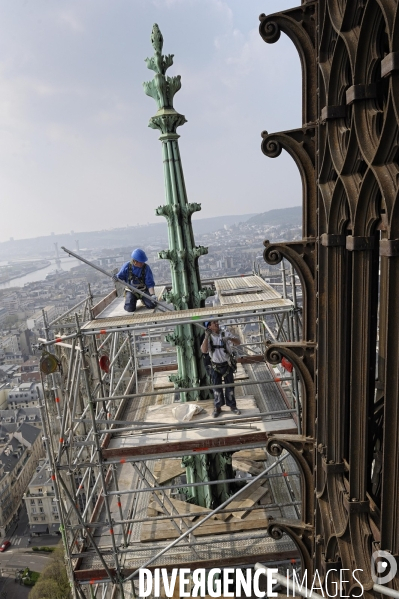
260, 0, 399, 595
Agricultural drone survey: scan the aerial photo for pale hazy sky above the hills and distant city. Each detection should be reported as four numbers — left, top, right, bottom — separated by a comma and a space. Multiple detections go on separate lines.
0, 0, 301, 241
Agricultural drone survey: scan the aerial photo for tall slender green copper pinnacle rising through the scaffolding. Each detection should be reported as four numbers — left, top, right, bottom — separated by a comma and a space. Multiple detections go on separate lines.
143, 24, 233, 507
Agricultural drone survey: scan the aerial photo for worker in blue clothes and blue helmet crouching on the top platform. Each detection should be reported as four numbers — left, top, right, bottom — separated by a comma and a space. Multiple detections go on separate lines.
113, 248, 157, 312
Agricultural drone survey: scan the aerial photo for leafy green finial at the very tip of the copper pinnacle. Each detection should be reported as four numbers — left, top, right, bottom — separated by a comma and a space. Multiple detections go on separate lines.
143, 23, 186, 133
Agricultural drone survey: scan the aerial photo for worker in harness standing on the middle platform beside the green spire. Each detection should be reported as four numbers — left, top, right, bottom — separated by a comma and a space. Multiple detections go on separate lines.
201, 320, 241, 418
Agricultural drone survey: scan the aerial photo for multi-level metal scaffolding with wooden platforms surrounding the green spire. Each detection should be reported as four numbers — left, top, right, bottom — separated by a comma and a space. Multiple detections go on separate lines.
40, 275, 301, 597
